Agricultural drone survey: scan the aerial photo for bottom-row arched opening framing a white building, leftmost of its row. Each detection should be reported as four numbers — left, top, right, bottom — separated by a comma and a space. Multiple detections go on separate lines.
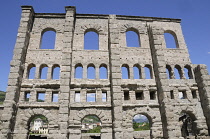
28, 115, 49, 139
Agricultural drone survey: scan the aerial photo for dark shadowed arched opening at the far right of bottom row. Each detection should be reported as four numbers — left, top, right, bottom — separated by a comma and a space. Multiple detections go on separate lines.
179, 112, 197, 137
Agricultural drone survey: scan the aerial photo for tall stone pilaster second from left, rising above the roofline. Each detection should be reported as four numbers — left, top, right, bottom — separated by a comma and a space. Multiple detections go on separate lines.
58, 6, 75, 139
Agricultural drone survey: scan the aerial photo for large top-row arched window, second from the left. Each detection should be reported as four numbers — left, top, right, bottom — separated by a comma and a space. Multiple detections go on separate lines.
84, 29, 99, 50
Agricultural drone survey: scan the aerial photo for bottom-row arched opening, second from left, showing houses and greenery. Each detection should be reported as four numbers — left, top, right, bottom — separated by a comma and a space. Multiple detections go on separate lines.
81, 115, 102, 135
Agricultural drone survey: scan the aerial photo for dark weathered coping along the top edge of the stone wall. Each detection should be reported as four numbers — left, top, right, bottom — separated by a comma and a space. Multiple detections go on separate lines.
21, 6, 181, 23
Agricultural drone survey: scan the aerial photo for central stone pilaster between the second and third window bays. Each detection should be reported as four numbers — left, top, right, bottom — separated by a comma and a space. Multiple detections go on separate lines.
109, 15, 123, 139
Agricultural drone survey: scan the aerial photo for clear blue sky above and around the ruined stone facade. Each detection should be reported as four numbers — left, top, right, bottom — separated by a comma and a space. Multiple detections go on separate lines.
0, 0, 210, 91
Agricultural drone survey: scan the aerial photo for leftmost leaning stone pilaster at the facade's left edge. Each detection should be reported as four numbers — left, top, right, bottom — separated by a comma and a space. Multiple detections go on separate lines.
0, 6, 34, 139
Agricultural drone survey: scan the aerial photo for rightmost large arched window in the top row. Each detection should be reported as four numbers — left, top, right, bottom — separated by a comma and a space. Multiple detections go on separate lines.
164, 30, 179, 48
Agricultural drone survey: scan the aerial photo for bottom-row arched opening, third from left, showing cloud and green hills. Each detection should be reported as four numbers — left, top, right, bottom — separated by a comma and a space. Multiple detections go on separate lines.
133, 114, 151, 131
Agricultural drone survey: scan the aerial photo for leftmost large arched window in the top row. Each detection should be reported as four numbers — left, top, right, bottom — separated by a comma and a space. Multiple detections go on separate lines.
40, 28, 56, 49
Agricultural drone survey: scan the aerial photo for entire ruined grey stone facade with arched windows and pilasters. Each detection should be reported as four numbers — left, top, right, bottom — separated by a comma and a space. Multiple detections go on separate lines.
0, 6, 210, 139
